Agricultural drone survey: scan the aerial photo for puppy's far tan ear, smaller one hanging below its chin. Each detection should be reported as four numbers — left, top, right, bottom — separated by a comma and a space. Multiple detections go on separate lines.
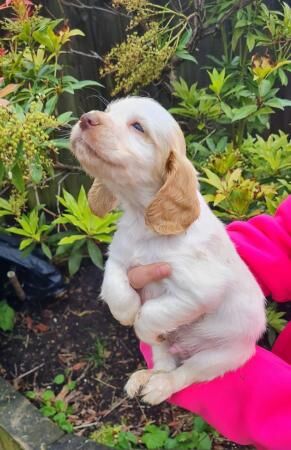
88, 178, 117, 217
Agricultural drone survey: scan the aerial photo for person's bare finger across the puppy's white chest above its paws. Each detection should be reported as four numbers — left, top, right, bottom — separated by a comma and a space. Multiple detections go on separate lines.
128, 263, 171, 289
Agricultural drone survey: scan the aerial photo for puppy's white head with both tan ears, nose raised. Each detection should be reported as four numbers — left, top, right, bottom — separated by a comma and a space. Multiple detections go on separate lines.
71, 97, 199, 235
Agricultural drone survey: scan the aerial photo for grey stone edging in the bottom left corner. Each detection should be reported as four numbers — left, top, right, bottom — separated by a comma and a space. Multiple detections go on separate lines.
0, 378, 109, 450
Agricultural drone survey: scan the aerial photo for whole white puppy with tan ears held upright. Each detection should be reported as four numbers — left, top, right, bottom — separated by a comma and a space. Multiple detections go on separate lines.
71, 97, 265, 404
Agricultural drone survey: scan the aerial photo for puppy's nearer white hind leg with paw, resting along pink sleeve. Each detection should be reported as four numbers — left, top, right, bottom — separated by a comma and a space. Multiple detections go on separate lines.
141, 344, 255, 405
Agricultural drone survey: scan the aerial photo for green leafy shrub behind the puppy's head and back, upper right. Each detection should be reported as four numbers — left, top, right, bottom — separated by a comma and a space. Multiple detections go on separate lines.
104, 0, 291, 220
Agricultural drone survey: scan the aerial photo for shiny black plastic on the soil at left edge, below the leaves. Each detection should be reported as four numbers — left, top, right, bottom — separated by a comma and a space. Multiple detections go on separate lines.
0, 234, 65, 303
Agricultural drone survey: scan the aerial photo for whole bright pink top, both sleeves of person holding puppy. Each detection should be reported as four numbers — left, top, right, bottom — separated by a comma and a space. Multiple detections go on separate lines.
141, 196, 291, 450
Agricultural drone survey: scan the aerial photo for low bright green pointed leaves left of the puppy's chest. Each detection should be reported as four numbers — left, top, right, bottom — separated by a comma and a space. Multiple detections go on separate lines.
0, 186, 120, 276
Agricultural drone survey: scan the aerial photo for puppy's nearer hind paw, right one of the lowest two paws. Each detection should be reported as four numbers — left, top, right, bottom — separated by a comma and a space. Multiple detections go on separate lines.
141, 372, 174, 405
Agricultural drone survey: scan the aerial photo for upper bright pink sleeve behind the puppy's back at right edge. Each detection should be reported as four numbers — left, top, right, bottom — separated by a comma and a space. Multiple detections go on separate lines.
227, 196, 291, 302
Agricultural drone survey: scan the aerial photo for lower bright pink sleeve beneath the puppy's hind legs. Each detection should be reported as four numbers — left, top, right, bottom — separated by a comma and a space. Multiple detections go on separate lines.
141, 344, 291, 450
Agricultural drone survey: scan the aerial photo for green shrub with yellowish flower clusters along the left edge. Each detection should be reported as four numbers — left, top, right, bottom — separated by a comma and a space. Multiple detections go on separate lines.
0, 0, 119, 275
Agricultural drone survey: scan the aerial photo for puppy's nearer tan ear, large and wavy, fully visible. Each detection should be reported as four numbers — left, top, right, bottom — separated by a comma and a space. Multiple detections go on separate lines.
145, 151, 200, 235
